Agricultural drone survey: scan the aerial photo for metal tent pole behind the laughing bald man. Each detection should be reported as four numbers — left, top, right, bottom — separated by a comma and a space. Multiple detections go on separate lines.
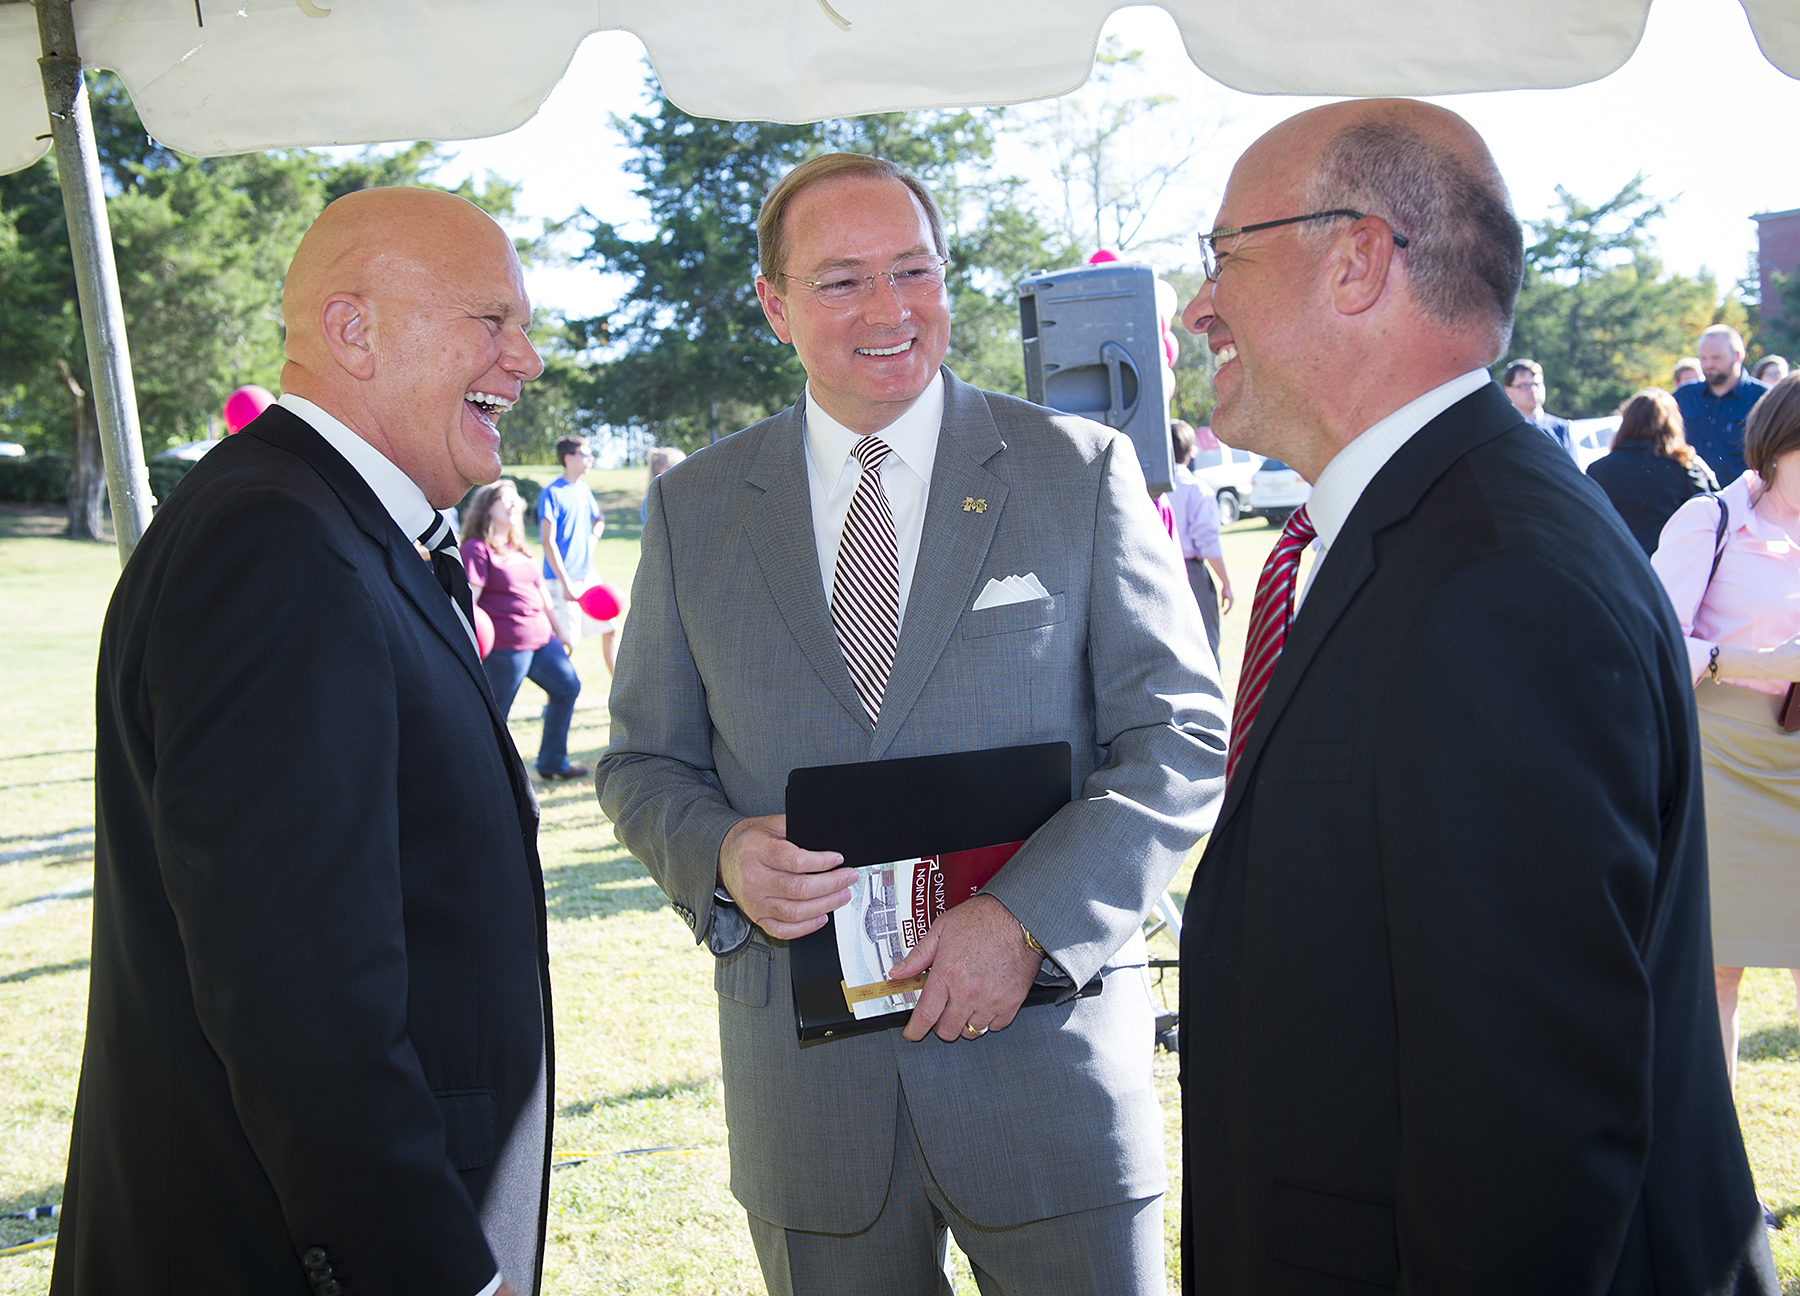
34, 0, 153, 565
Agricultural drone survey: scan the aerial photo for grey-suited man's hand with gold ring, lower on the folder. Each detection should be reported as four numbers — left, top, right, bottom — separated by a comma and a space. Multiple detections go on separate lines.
893, 895, 1044, 1044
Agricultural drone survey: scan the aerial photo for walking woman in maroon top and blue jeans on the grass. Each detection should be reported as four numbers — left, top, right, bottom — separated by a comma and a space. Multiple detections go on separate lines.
463, 481, 587, 778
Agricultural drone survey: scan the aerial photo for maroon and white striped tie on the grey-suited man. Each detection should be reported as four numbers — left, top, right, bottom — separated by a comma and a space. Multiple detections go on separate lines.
832, 436, 900, 725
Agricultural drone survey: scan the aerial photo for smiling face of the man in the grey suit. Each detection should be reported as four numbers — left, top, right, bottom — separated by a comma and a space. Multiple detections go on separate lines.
756, 175, 950, 436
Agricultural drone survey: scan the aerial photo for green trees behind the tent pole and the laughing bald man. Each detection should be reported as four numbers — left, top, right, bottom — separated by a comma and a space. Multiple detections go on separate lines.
0, 74, 536, 536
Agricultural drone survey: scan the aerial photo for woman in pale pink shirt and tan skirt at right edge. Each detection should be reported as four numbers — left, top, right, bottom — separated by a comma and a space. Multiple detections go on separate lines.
1651, 374, 1800, 1123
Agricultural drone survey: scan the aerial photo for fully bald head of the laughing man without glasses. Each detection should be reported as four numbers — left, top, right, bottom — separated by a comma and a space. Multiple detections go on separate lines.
281, 189, 544, 508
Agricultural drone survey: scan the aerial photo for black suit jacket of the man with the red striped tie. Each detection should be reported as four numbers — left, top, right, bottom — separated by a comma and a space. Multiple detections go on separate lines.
1181, 385, 1777, 1296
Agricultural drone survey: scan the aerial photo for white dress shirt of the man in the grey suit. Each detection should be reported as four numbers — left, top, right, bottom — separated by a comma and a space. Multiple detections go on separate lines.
805, 374, 943, 625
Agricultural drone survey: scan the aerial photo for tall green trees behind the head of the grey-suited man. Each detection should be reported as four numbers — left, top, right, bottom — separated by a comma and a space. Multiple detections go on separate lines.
569, 87, 1053, 448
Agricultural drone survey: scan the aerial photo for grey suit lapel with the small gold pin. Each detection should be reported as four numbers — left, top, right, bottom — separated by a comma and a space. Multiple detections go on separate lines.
867, 369, 1006, 760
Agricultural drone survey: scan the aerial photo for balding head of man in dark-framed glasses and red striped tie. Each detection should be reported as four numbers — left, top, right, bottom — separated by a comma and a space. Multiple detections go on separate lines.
1183, 99, 1525, 481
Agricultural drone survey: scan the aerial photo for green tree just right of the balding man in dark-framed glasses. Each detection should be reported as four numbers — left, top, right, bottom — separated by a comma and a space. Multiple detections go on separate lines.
1496, 175, 1723, 418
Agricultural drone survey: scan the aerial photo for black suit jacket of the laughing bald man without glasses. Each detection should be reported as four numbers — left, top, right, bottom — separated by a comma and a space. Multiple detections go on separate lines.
52, 407, 551, 1296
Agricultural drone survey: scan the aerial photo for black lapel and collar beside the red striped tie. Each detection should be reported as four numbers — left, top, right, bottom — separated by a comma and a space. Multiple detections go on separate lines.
1219, 383, 1530, 828
